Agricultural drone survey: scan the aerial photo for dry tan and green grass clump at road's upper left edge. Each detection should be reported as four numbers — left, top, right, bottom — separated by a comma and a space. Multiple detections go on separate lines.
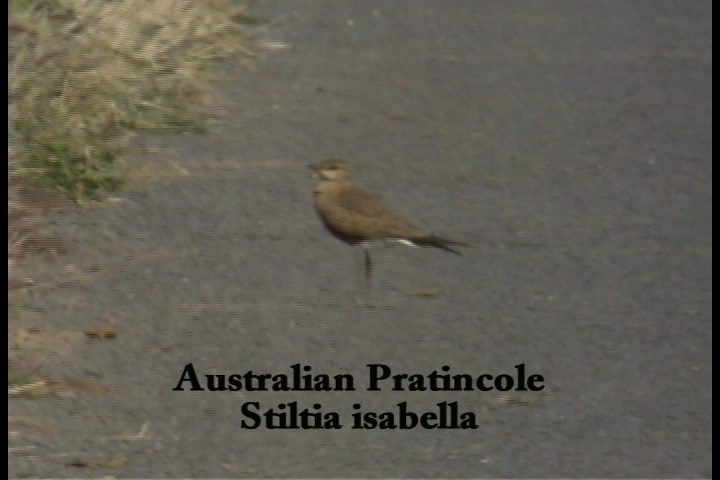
8, 0, 252, 202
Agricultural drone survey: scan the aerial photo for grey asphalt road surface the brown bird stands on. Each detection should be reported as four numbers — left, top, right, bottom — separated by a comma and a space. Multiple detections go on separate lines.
9, 0, 712, 478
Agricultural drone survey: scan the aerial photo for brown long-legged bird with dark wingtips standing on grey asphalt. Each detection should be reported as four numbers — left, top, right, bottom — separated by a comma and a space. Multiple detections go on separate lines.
309, 158, 469, 296
